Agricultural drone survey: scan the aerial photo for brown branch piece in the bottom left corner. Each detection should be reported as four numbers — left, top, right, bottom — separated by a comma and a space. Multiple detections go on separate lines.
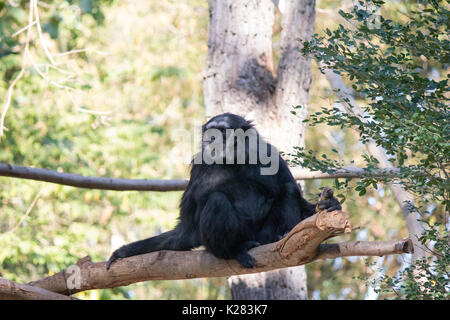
0, 278, 75, 300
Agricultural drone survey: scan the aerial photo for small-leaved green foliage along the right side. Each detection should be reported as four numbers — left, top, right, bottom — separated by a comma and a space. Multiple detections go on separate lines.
294, 0, 450, 299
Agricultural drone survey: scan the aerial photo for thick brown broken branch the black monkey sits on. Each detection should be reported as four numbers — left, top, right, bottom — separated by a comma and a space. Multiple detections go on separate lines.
29, 211, 410, 294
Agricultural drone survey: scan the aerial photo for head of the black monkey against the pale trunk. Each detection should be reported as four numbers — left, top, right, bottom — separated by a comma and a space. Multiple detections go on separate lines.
202, 113, 258, 164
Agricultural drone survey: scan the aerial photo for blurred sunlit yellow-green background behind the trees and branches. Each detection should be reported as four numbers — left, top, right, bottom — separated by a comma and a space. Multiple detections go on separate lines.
0, 0, 413, 299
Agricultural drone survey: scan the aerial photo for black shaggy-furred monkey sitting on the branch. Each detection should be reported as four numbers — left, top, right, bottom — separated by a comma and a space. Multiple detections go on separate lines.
106, 113, 341, 269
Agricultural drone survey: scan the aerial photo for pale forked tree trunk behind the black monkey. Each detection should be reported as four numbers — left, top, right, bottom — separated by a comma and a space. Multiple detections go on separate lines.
203, 0, 315, 299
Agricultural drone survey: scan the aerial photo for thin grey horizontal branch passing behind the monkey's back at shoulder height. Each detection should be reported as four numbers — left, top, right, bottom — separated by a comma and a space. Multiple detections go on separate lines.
0, 163, 399, 191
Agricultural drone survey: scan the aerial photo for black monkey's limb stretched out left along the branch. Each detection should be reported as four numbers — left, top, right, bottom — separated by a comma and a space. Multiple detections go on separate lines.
106, 226, 199, 270
